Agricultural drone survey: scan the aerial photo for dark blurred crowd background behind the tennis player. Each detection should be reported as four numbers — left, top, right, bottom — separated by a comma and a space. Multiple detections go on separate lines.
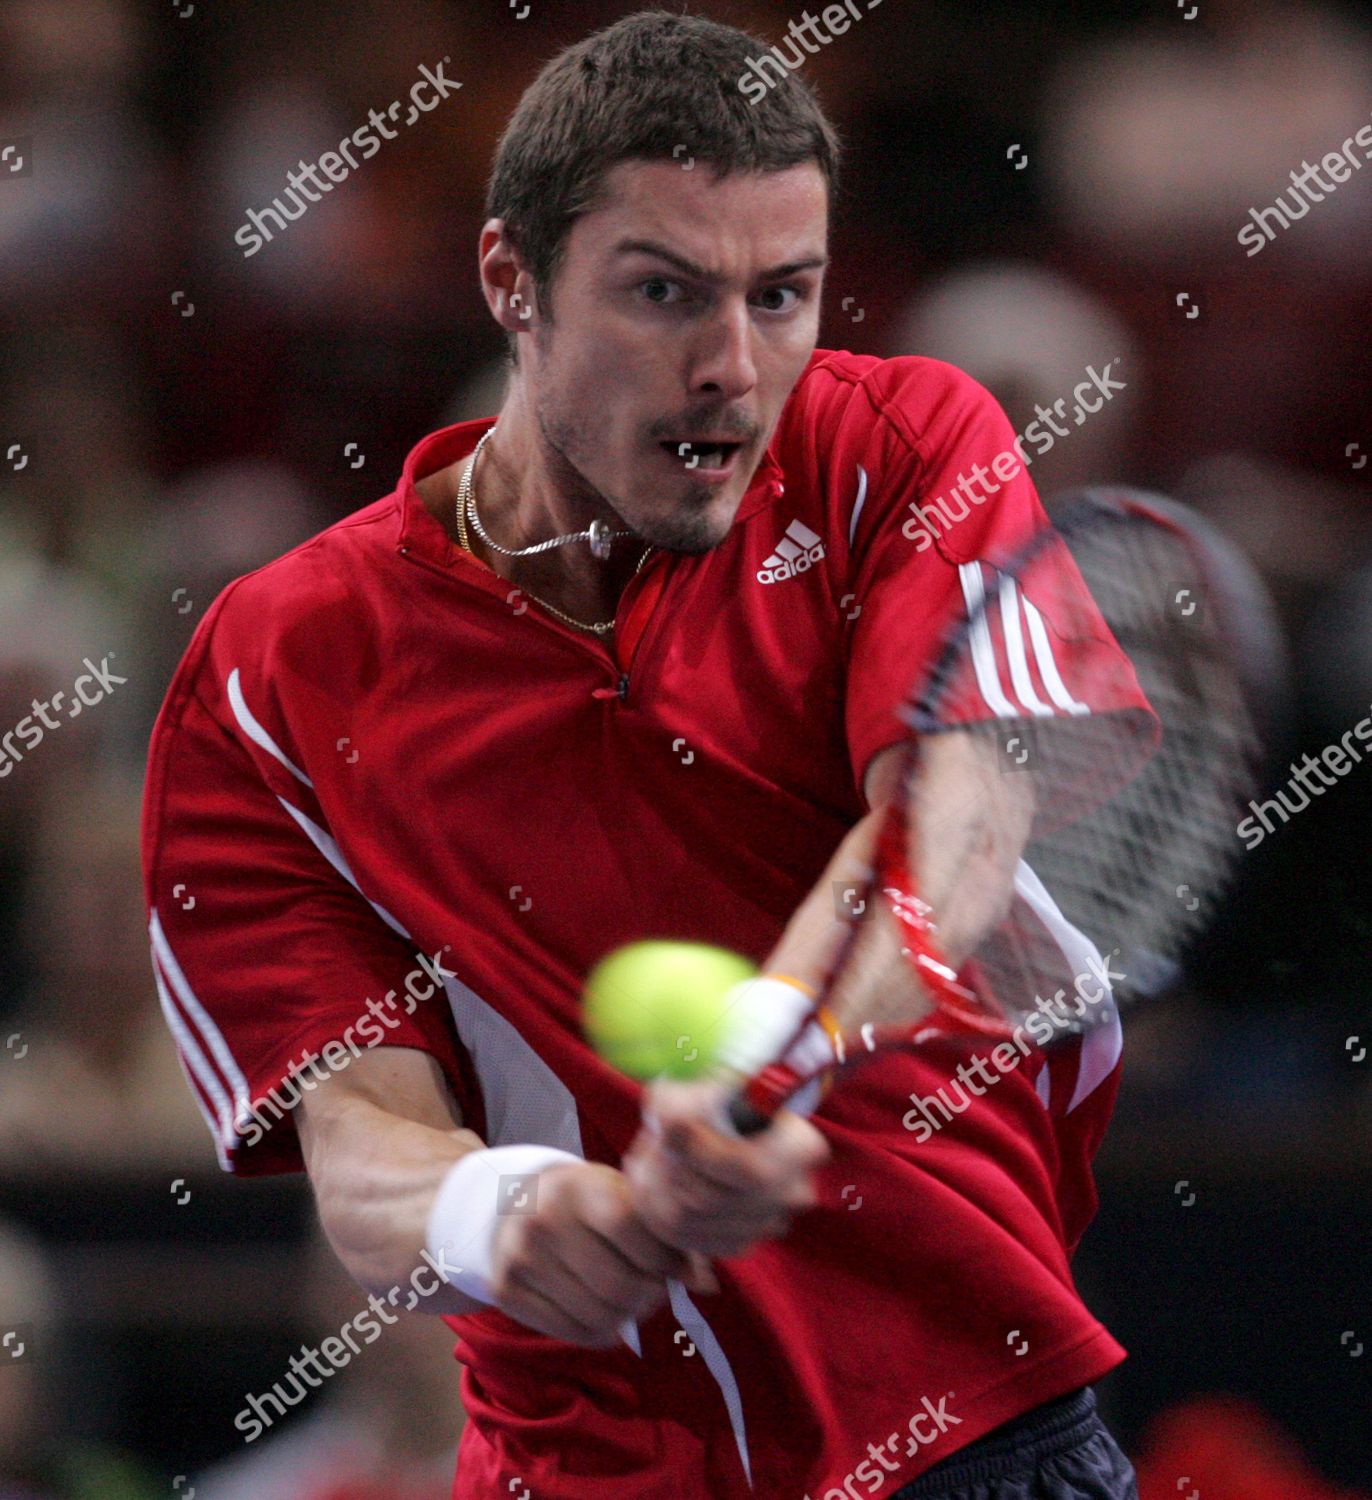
0, 0, 1372, 1500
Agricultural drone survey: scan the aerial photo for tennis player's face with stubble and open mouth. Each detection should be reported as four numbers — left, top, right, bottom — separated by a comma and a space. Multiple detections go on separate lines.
520, 162, 828, 552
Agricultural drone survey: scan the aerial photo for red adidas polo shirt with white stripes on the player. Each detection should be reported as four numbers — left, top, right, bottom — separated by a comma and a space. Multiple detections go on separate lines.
145, 351, 1138, 1500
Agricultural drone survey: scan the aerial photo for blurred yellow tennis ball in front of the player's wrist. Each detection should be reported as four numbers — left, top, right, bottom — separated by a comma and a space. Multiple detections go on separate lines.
585, 941, 757, 1079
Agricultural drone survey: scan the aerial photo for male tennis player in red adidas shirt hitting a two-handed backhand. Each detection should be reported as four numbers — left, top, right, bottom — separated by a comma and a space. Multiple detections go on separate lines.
145, 12, 1135, 1500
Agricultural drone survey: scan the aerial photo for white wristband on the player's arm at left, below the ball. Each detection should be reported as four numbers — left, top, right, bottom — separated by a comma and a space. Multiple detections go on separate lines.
424, 1146, 583, 1307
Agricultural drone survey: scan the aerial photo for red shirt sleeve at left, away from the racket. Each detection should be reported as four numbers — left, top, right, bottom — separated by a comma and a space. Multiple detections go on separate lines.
142, 594, 462, 1176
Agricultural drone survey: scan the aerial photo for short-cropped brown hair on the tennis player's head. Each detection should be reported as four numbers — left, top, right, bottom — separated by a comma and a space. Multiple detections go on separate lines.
486, 11, 841, 353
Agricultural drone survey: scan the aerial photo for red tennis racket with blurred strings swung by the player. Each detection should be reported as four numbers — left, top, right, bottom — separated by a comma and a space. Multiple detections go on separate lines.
724, 489, 1273, 1134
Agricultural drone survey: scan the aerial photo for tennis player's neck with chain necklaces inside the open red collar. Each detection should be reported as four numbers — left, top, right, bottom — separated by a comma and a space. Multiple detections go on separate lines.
417, 387, 643, 624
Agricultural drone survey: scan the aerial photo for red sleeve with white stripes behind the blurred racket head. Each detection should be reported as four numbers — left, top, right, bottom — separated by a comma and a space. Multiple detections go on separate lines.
844, 359, 1147, 794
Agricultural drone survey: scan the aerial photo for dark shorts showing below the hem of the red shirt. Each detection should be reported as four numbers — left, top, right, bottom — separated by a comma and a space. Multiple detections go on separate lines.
891, 1386, 1138, 1500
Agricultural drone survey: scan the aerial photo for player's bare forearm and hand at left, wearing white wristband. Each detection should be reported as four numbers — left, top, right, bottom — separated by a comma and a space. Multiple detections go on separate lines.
297, 1047, 718, 1349
